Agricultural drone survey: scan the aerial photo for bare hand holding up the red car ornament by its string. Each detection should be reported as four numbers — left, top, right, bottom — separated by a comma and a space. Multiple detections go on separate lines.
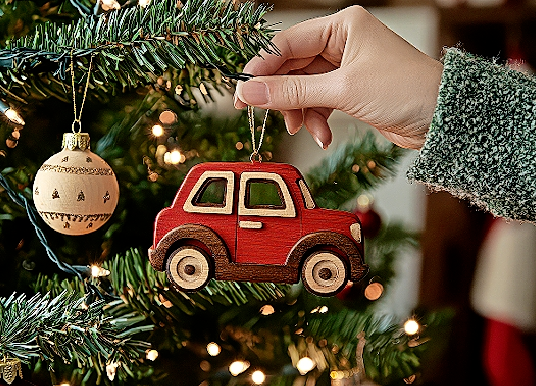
235, 6, 443, 149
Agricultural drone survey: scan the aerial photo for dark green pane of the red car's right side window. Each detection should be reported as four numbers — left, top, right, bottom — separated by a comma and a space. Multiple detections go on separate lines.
245, 178, 285, 209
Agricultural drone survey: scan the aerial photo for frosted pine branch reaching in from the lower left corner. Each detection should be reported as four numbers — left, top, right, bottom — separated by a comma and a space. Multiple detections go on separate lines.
0, 291, 153, 367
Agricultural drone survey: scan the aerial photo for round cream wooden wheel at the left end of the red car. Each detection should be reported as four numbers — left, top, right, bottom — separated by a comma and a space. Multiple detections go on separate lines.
166, 245, 212, 292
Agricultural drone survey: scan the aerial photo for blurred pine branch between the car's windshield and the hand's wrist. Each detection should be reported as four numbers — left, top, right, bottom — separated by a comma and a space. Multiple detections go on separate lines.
306, 132, 404, 209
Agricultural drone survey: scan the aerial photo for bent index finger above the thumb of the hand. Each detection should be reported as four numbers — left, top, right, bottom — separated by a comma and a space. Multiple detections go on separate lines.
244, 15, 333, 75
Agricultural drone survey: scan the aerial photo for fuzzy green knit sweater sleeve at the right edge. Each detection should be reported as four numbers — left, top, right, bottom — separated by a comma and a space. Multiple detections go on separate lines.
408, 48, 536, 221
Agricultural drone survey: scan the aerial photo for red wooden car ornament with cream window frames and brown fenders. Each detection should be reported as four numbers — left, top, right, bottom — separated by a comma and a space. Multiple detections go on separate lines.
149, 162, 368, 296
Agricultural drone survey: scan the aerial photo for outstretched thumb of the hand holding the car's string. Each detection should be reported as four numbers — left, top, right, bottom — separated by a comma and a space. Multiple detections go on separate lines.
236, 73, 340, 110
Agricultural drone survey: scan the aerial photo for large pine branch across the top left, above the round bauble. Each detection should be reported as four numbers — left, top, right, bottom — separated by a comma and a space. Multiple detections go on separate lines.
0, 0, 276, 101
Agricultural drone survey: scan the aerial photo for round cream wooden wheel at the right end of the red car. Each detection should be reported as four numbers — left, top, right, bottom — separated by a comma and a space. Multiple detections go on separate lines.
301, 251, 348, 296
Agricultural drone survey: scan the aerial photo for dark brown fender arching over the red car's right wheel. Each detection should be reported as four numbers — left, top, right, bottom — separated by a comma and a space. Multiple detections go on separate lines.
287, 232, 368, 281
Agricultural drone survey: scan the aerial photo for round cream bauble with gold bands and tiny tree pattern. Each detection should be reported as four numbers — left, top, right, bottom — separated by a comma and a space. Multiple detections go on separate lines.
33, 133, 119, 236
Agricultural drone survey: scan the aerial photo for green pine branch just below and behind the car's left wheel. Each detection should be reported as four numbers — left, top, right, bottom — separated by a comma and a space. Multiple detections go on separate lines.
34, 249, 288, 324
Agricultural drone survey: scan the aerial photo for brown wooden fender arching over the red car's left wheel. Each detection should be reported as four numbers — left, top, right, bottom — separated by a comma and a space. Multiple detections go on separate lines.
149, 224, 229, 271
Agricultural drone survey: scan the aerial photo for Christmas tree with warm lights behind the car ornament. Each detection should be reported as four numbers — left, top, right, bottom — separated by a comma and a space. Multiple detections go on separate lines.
0, 0, 443, 385
